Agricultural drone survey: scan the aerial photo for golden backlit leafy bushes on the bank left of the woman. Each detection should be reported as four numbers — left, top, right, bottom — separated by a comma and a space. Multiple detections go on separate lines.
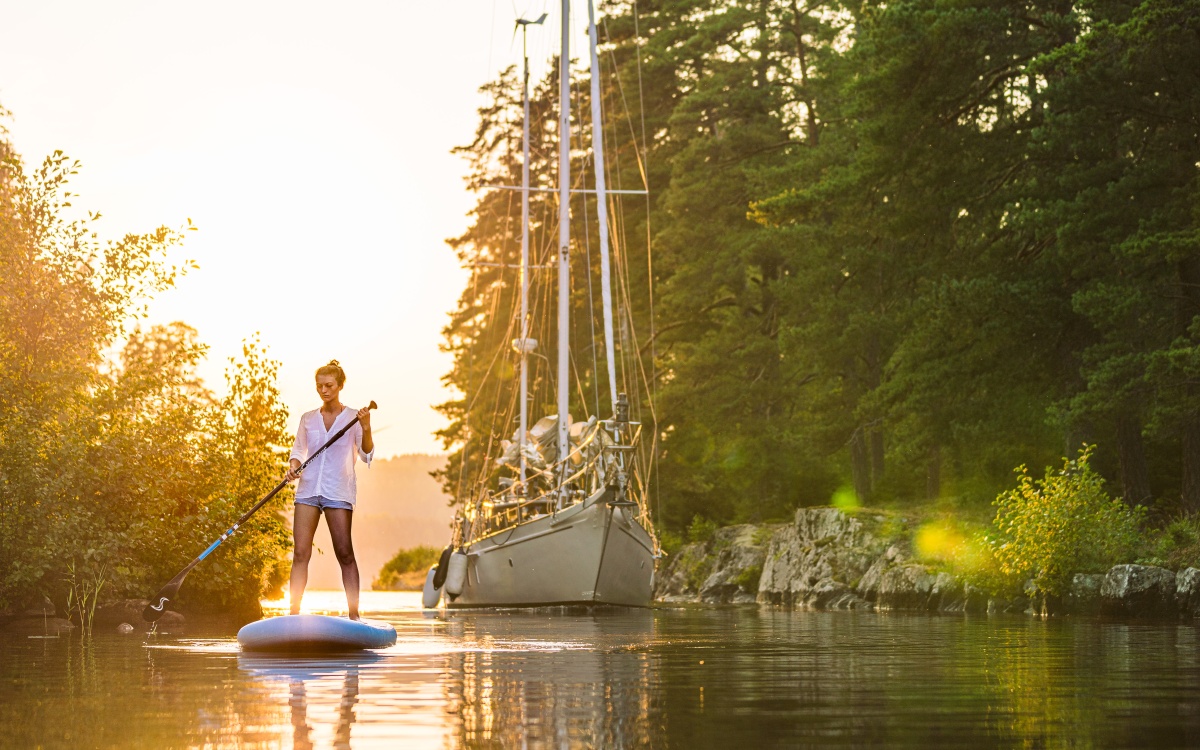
0, 133, 288, 613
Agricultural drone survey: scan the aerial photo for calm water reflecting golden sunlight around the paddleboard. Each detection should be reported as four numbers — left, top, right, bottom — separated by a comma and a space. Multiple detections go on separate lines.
0, 593, 1200, 750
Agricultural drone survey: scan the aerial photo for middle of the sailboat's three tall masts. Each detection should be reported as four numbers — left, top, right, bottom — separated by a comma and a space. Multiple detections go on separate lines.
558, 0, 571, 489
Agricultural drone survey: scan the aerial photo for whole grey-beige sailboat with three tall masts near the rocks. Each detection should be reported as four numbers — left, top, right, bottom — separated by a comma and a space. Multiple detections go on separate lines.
425, 0, 661, 607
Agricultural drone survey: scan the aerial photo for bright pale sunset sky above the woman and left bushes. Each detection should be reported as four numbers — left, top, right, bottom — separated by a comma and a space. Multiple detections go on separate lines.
0, 0, 587, 457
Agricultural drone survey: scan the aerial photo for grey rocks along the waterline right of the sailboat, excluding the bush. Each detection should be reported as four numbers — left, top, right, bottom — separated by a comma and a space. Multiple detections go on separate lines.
654, 508, 1200, 619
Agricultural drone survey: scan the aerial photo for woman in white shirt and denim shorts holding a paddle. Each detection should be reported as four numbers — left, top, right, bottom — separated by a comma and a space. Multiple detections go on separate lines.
286, 359, 374, 619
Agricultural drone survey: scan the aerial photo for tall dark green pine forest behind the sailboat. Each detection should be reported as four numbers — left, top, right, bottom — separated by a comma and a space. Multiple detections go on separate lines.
444, 0, 1200, 532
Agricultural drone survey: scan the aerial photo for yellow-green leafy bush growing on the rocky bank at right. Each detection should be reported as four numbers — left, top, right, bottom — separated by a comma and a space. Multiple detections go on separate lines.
988, 445, 1144, 595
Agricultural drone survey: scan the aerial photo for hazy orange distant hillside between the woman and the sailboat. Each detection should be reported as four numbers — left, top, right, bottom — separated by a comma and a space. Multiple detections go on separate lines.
308, 455, 452, 590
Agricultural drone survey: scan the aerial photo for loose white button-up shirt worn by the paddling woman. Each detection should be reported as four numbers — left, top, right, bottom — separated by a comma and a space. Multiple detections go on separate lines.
290, 407, 374, 505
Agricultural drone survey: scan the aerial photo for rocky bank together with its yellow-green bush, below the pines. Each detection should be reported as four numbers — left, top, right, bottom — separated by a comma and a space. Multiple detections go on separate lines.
655, 446, 1200, 618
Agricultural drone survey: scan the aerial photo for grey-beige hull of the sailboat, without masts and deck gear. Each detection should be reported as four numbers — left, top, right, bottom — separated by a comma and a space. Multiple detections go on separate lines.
448, 491, 654, 607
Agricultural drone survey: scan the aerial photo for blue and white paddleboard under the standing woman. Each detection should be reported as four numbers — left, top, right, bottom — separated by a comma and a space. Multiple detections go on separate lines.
238, 614, 396, 653
